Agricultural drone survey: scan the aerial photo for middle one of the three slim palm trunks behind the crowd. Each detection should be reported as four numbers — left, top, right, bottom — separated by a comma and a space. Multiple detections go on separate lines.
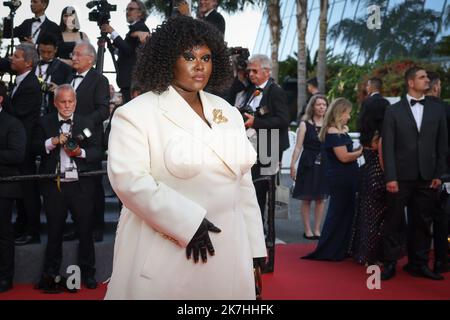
296, 0, 308, 120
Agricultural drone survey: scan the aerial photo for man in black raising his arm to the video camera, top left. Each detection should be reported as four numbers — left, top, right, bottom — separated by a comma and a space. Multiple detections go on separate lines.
101, 0, 150, 103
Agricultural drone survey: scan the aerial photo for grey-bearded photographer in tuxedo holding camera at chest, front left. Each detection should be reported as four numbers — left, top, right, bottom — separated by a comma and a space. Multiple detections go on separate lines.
33, 84, 101, 289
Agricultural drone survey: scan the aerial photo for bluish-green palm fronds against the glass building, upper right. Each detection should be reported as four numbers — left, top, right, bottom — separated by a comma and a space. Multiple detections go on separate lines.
330, 0, 439, 62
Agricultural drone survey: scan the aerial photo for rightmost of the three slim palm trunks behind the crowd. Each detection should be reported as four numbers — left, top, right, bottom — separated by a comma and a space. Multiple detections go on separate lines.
317, 0, 328, 92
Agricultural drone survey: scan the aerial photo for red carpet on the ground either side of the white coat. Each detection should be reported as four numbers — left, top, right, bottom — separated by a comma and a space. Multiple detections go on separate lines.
0, 244, 450, 300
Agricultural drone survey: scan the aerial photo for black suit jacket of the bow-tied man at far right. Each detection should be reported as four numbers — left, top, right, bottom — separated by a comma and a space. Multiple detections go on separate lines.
383, 97, 448, 182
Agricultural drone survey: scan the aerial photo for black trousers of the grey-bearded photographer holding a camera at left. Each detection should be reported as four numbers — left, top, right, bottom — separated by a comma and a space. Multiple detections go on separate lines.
44, 177, 95, 276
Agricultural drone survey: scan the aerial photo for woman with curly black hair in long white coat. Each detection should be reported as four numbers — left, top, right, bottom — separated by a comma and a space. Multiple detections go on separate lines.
106, 17, 266, 299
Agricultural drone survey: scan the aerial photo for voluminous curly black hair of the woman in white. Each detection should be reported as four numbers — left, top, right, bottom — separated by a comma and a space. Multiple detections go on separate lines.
133, 16, 232, 94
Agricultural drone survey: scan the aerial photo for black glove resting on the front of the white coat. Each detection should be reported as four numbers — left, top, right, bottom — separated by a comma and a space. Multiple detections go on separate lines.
186, 218, 222, 263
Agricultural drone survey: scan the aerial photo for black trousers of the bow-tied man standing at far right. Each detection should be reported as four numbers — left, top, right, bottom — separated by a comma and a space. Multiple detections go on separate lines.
383, 180, 437, 266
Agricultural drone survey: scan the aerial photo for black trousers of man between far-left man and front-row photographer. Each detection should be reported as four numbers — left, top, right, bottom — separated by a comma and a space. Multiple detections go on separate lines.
16, 160, 41, 235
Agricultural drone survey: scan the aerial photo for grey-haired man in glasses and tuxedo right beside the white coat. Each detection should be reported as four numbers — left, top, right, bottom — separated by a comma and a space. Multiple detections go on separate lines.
241, 54, 289, 228
